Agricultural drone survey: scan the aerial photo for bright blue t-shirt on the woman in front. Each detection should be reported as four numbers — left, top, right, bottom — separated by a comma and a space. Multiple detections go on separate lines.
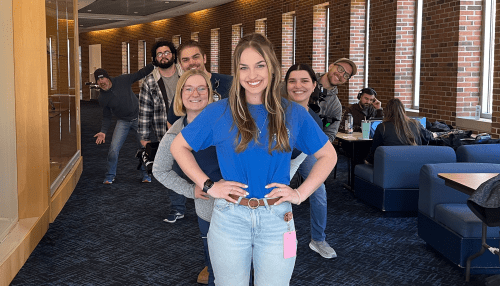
182, 99, 328, 198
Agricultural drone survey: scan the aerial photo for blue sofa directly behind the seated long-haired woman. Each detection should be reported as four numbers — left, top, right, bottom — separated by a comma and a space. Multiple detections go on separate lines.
354, 146, 456, 215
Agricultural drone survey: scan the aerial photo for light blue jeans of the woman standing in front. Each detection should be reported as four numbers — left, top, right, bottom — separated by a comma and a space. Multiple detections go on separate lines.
208, 199, 297, 286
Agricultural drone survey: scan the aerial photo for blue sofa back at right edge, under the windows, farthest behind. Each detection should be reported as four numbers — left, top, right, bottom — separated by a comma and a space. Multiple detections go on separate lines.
457, 144, 500, 164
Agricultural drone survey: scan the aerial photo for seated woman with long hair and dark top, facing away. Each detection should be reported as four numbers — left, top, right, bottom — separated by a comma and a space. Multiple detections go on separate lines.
366, 98, 434, 164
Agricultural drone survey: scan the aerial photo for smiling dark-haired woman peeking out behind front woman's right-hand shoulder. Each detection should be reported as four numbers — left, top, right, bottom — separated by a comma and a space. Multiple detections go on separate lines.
285, 64, 337, 258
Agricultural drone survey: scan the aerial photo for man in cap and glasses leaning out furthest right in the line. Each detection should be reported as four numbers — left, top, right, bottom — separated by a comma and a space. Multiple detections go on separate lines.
316, 58, 358, 143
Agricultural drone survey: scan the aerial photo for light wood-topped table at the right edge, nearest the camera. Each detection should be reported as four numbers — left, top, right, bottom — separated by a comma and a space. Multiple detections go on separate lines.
438, 173, 498, 282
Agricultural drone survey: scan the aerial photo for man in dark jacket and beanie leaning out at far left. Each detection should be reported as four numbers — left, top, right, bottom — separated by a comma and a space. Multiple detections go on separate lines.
94, 64, 154, 185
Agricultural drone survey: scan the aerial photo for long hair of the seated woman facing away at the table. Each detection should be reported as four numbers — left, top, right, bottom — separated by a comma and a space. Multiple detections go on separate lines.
383, 98, 420, 145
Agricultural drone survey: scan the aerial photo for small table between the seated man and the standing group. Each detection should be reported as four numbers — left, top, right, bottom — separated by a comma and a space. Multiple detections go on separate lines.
334, 132, 372, 191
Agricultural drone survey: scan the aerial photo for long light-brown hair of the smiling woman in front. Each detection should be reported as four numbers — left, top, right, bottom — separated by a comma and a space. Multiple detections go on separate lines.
229, 33, 291, 153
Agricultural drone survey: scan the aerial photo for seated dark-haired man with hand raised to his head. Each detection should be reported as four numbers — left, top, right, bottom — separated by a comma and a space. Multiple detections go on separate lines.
339, 87, 384, 132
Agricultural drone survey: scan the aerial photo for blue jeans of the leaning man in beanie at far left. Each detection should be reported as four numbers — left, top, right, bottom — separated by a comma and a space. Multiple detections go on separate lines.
105, 119, 148, 180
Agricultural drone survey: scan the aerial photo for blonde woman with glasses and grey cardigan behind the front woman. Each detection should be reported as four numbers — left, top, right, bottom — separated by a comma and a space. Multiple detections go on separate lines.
153, 70, 218, 285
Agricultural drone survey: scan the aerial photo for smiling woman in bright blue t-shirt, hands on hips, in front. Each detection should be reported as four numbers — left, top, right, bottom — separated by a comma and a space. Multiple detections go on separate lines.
171, 33, 337, 286
